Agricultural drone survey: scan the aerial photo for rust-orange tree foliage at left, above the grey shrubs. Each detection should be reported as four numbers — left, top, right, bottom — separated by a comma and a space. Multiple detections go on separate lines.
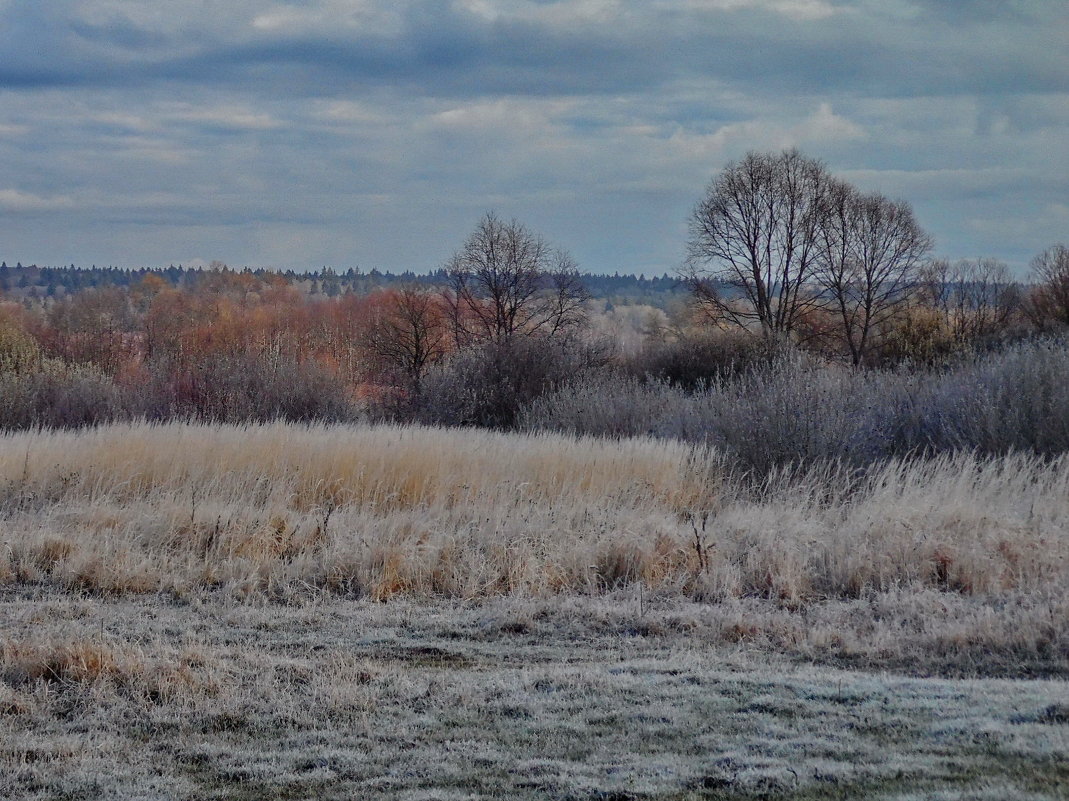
9, 268, 448, 397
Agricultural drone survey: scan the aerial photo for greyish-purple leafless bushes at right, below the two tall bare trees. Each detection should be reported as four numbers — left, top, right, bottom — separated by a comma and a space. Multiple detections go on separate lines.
521, 340, 1069, 473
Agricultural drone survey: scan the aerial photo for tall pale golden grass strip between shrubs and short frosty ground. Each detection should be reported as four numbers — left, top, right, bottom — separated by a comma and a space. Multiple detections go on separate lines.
0, 423, 1069, 605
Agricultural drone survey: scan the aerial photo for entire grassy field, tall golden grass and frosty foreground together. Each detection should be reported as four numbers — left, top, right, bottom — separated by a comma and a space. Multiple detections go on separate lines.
0, 423, 1069, 800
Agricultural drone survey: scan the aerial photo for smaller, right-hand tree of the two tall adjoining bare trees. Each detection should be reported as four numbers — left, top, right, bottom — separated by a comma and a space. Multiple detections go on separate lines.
815, 181, 932, 365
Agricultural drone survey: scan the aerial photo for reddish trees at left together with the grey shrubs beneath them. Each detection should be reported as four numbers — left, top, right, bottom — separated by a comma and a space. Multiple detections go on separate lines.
0, 271, 468, 425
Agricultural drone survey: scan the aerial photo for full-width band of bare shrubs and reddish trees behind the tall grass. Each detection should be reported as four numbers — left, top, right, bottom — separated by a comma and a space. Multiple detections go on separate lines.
0, 227, 1069, 475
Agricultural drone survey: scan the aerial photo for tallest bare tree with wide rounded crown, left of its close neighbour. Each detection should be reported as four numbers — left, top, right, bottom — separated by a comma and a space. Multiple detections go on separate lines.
683, 150, 831, 336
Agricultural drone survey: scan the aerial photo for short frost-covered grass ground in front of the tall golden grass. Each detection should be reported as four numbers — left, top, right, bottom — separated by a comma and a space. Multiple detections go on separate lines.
0, 588, 1069, 801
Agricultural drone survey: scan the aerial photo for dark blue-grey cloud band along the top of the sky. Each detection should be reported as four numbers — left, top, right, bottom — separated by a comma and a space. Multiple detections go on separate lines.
0, 0, 1069, 103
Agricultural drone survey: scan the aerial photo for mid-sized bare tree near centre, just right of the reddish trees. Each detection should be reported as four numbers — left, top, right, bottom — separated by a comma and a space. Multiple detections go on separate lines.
446, 213, 589, 346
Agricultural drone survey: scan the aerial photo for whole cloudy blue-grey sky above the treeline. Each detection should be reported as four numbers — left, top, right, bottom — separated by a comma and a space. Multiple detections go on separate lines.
0, 0, 1069, 275
